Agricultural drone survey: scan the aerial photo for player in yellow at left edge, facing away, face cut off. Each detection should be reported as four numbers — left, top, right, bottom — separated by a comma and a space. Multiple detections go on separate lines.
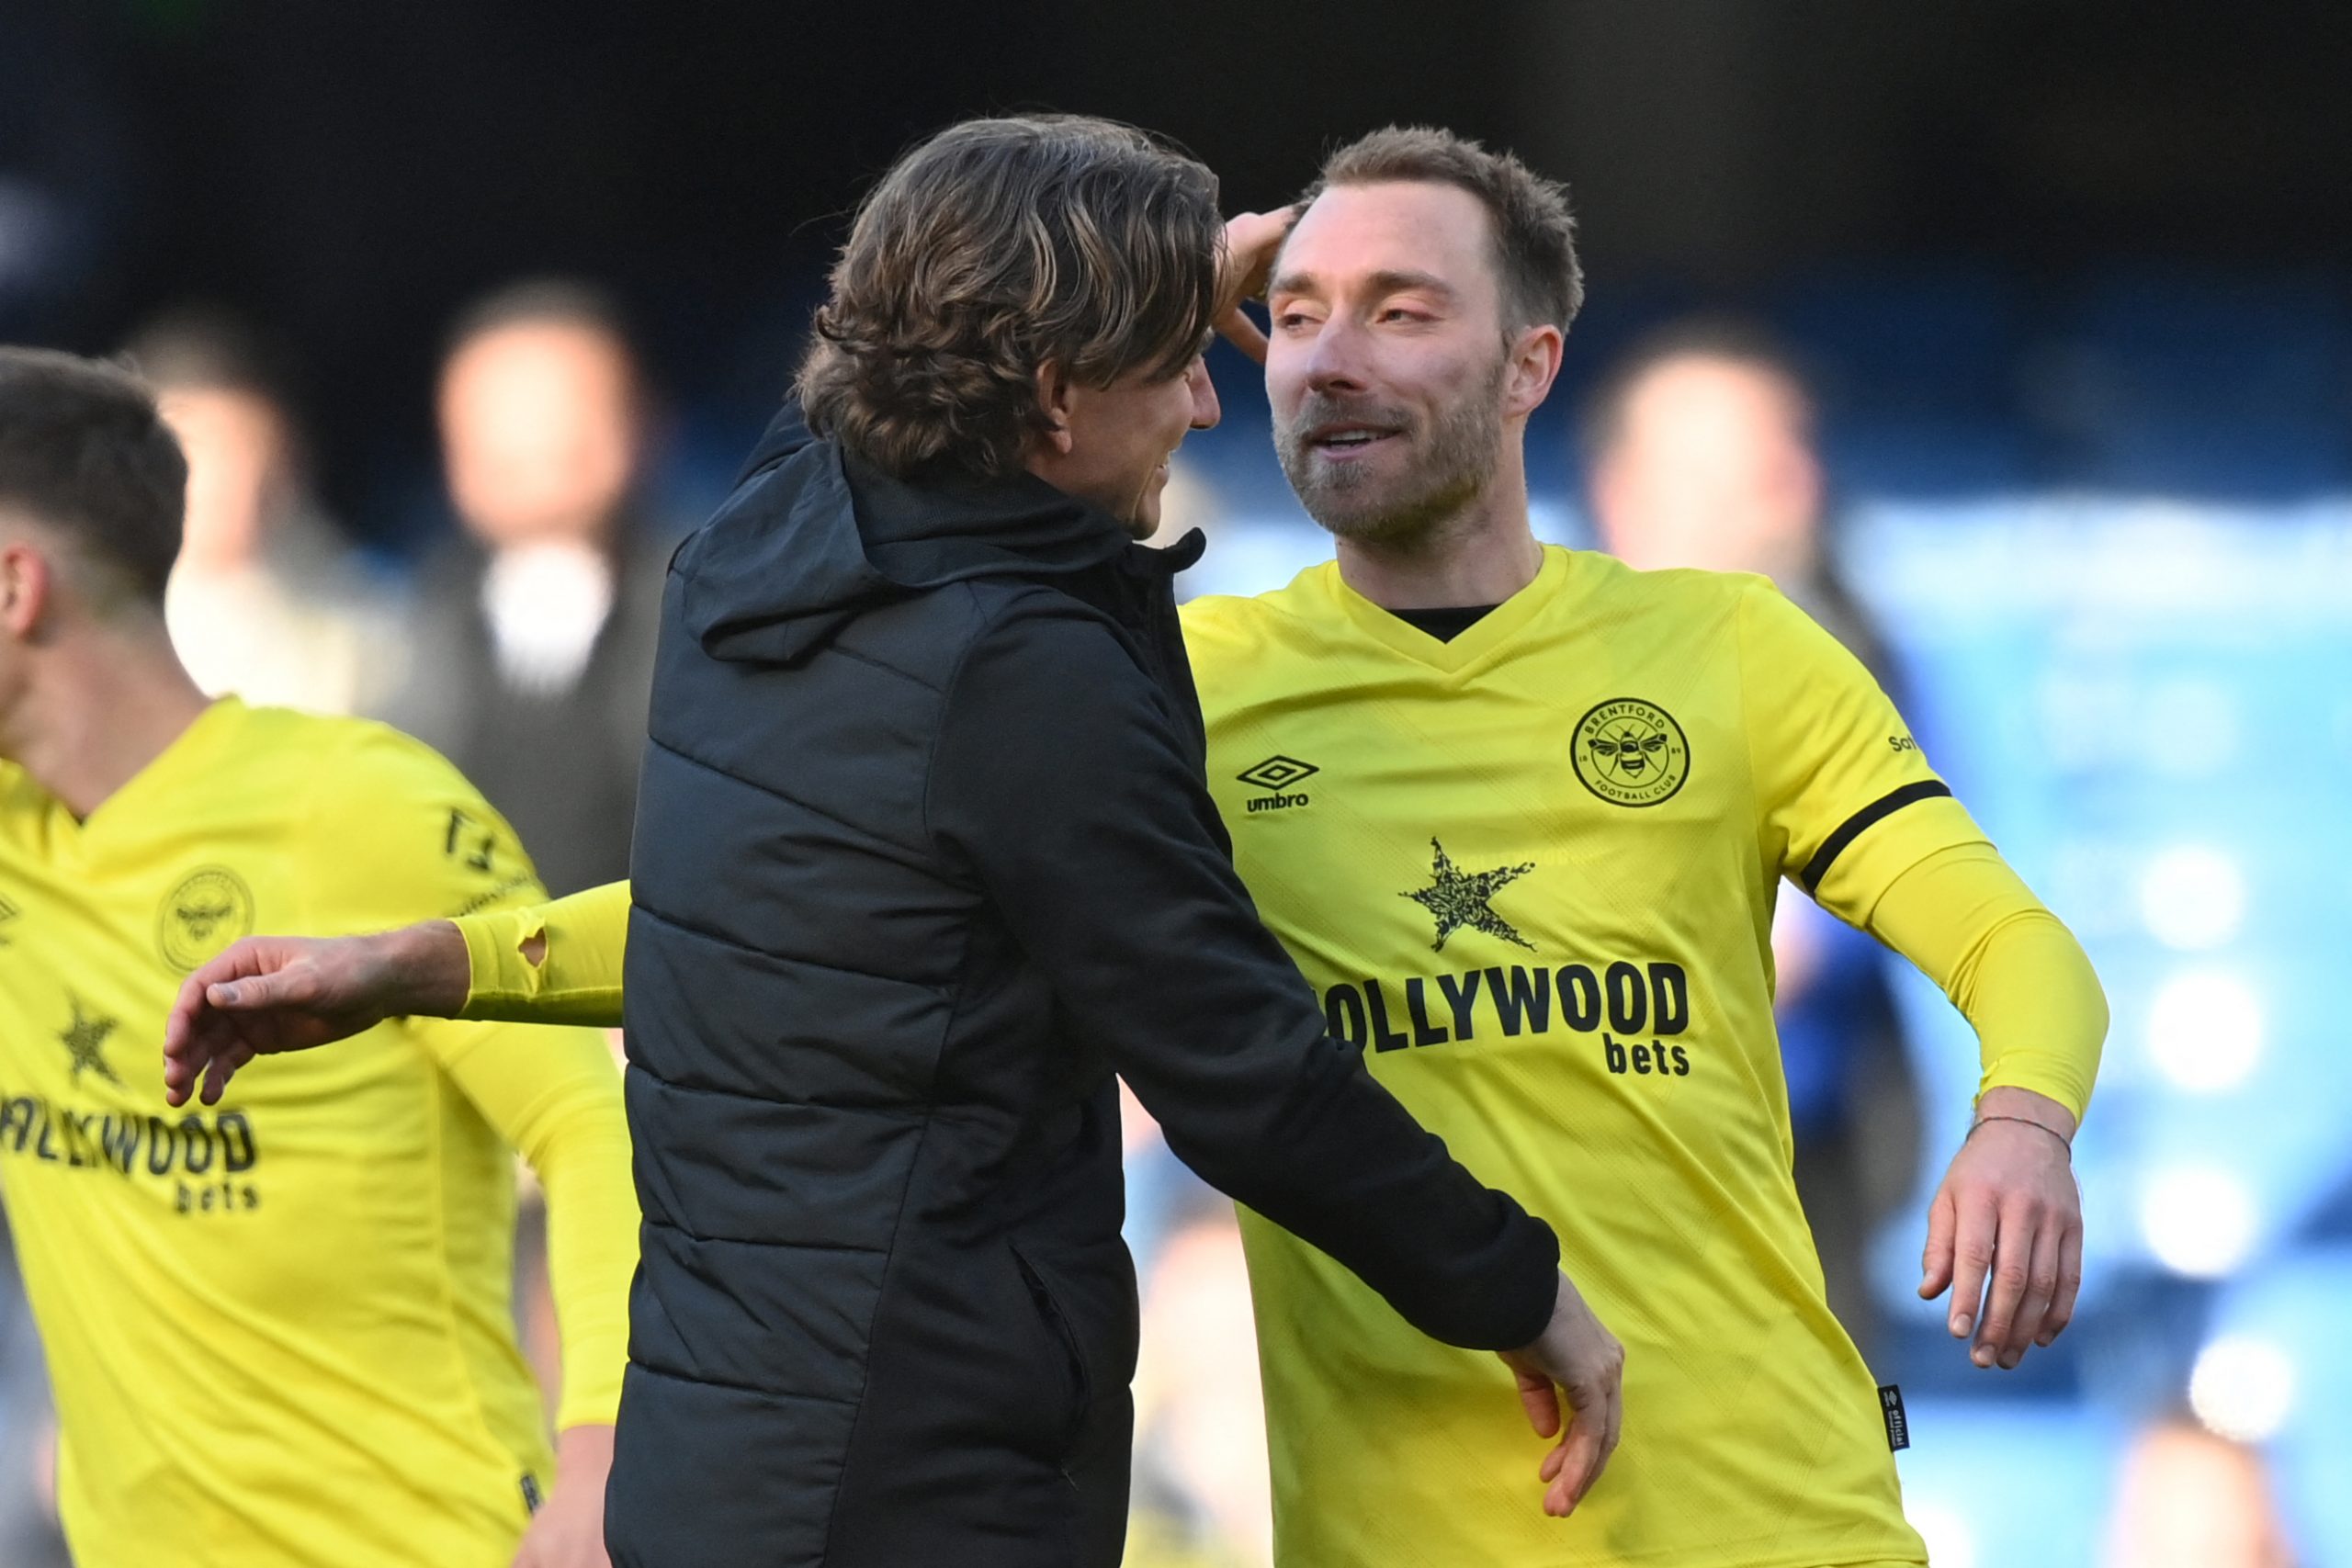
0, 350, 638, 1568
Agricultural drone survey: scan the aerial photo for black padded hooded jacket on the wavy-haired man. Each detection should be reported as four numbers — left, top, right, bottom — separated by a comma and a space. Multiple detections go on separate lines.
606, 412, 1557, 1568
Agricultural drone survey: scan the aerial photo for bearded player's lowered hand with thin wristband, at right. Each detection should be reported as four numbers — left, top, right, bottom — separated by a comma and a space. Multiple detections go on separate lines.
1919, 1089, 2082, 1368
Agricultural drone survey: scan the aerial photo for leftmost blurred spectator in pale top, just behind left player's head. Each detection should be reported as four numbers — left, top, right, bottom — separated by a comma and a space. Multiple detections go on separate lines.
125, 310, 400, 712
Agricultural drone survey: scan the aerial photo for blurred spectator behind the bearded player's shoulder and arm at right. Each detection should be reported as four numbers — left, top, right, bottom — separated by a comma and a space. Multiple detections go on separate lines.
1583, 317, 1919, 1357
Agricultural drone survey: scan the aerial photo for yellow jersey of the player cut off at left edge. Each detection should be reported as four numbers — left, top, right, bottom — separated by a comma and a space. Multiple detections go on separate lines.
0, 698, 635, 1568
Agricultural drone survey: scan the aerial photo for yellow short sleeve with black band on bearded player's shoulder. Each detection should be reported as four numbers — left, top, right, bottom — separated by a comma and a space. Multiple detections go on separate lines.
1738, 579, 1985, 929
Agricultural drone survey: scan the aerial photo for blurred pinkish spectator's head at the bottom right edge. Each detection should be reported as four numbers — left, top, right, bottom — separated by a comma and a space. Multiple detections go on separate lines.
2103, 1416, 2296, 1568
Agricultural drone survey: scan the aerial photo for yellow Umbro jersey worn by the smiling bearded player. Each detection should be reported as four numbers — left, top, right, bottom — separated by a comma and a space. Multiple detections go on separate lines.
1185, 547, 1981, 1568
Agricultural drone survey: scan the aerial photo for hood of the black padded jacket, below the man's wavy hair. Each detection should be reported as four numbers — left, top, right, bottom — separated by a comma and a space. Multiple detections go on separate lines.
673, 407, 1202, 663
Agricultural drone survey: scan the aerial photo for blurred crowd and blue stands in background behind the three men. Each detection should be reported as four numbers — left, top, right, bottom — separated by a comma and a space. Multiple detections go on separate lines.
0, 251, 2352, 1568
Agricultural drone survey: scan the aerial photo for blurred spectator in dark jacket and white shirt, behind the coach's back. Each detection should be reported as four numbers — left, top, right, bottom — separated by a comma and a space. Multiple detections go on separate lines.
386, 282, 663, 896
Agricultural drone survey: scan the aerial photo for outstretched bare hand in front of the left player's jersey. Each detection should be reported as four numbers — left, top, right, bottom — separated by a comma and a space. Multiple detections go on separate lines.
163, 919, 470, 1105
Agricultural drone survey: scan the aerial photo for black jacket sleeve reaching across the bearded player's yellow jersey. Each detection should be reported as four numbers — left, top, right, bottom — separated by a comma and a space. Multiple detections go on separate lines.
927, 614, 1559, 1349
